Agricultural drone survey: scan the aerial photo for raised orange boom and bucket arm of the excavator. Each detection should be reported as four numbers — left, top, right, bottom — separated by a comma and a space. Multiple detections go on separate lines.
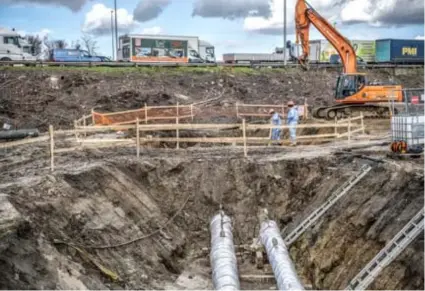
295, 0, 357, 74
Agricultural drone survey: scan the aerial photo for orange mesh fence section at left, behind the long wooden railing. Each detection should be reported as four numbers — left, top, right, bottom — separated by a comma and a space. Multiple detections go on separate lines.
74, 103, 195, 127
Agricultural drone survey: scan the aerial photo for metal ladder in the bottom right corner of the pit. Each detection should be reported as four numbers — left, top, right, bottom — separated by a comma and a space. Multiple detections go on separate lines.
345, 208, 424, 290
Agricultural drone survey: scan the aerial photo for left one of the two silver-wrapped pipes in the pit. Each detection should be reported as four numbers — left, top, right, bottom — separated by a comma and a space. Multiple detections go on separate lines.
210, 211, 240, 290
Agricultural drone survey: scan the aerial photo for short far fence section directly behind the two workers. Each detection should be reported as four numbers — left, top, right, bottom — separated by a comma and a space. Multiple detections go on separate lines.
235, 100, 309, 119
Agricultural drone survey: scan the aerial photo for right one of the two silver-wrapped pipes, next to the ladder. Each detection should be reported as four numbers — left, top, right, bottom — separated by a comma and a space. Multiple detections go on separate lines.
260, 220, 304, 290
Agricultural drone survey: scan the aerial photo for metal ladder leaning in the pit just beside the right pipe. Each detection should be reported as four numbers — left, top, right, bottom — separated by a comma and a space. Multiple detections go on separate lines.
284, 165, 372, 247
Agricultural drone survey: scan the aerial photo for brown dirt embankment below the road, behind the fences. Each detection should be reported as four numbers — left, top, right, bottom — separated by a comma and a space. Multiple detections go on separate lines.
0, 67, 424, 131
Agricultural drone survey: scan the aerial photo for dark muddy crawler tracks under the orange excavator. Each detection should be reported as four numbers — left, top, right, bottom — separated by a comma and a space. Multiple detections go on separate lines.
312, 104, 397, 120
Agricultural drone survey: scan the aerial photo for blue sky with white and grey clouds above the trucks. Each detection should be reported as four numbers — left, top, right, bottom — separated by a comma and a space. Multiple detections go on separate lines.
0, 0, 424, 59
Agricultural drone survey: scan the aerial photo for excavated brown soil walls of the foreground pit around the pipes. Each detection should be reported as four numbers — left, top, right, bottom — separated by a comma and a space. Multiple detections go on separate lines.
0, 141, 424, 290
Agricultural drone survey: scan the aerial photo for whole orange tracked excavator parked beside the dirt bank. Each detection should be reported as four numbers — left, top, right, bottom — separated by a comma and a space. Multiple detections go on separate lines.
295, 0, 403, 119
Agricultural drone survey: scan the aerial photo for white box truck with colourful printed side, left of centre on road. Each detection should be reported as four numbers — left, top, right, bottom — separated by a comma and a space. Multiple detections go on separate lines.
117, 34, 216, 63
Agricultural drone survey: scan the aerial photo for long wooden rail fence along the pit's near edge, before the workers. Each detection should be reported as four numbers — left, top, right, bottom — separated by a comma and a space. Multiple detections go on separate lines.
0, 115, 365, 171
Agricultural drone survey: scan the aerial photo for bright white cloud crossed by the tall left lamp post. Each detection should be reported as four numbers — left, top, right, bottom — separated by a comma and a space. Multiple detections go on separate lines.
82, 4, 139, 35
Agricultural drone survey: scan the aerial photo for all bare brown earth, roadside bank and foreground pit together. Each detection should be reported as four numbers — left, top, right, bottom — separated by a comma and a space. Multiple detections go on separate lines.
0, 68, 424, 290
